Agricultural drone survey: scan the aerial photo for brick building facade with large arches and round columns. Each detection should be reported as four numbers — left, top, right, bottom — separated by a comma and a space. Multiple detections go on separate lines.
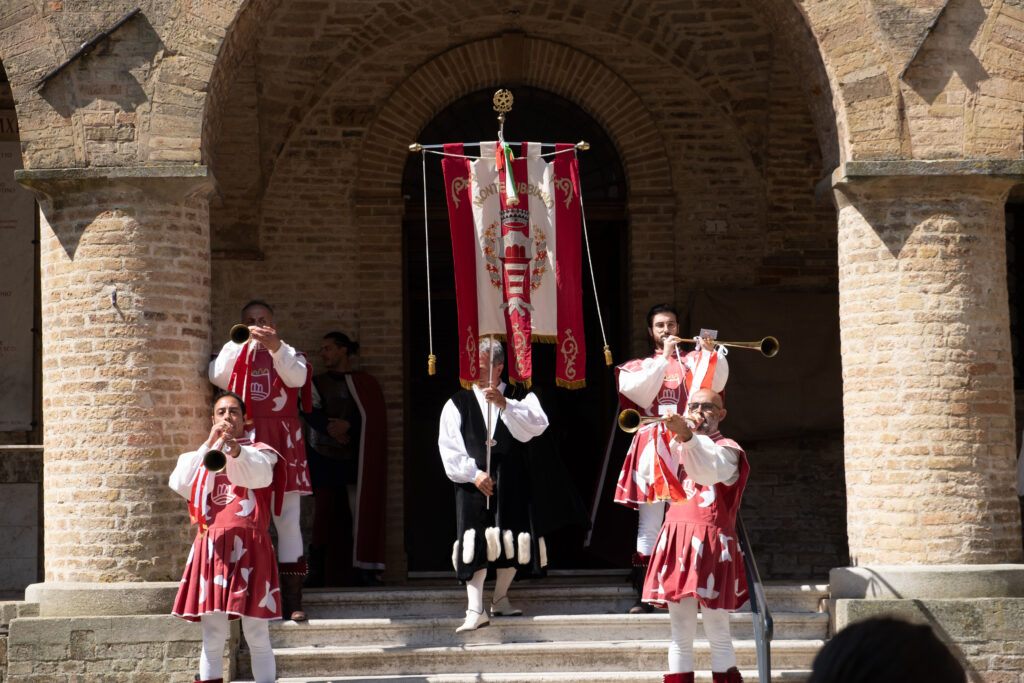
0, 0, 1024, 681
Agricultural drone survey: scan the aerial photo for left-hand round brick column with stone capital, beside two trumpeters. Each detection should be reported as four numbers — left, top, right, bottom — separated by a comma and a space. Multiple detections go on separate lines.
18, 166, 211, 593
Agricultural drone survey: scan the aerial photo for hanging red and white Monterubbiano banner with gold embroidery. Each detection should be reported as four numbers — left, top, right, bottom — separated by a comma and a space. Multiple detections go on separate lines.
441, 142, 587, 389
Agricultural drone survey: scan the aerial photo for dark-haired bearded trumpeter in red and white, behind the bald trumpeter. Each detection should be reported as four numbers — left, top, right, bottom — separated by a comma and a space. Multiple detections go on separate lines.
614, 303, 729, 613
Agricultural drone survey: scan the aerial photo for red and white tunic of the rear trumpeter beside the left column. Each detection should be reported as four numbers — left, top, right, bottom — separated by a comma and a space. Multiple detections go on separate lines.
210, 341, 312, 507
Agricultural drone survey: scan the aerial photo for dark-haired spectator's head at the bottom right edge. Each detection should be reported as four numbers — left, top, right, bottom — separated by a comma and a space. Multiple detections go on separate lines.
807, 617, 967, 683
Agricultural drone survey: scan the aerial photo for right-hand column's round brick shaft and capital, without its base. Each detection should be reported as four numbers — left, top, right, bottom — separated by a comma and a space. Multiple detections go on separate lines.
836, 175, 1022, 565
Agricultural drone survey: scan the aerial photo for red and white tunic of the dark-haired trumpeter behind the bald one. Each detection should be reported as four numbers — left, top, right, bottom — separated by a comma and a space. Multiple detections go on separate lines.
614, 347, 729, 510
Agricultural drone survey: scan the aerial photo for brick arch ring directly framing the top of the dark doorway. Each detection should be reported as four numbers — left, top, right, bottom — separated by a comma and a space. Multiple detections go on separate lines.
357, 38, 674, 196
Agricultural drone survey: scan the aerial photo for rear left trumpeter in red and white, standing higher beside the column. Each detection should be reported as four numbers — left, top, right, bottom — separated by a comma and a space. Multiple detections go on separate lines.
210, 300, 312, 622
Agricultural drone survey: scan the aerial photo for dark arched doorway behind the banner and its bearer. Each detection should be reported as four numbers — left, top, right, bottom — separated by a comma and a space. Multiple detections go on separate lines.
402, 88, 636, 574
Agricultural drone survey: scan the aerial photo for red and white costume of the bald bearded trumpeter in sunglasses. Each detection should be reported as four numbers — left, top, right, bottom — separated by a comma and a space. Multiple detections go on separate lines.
643, 432, 750, 609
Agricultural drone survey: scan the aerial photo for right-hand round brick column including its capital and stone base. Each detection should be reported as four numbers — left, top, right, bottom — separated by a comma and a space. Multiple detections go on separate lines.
829, 162, 1024, 681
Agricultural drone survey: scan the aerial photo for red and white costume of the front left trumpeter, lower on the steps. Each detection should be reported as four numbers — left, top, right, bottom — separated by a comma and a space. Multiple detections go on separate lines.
168, 439, 281, 622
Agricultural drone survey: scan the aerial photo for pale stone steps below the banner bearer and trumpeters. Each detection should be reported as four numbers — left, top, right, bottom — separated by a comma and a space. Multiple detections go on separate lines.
238, 578, 828, 683
